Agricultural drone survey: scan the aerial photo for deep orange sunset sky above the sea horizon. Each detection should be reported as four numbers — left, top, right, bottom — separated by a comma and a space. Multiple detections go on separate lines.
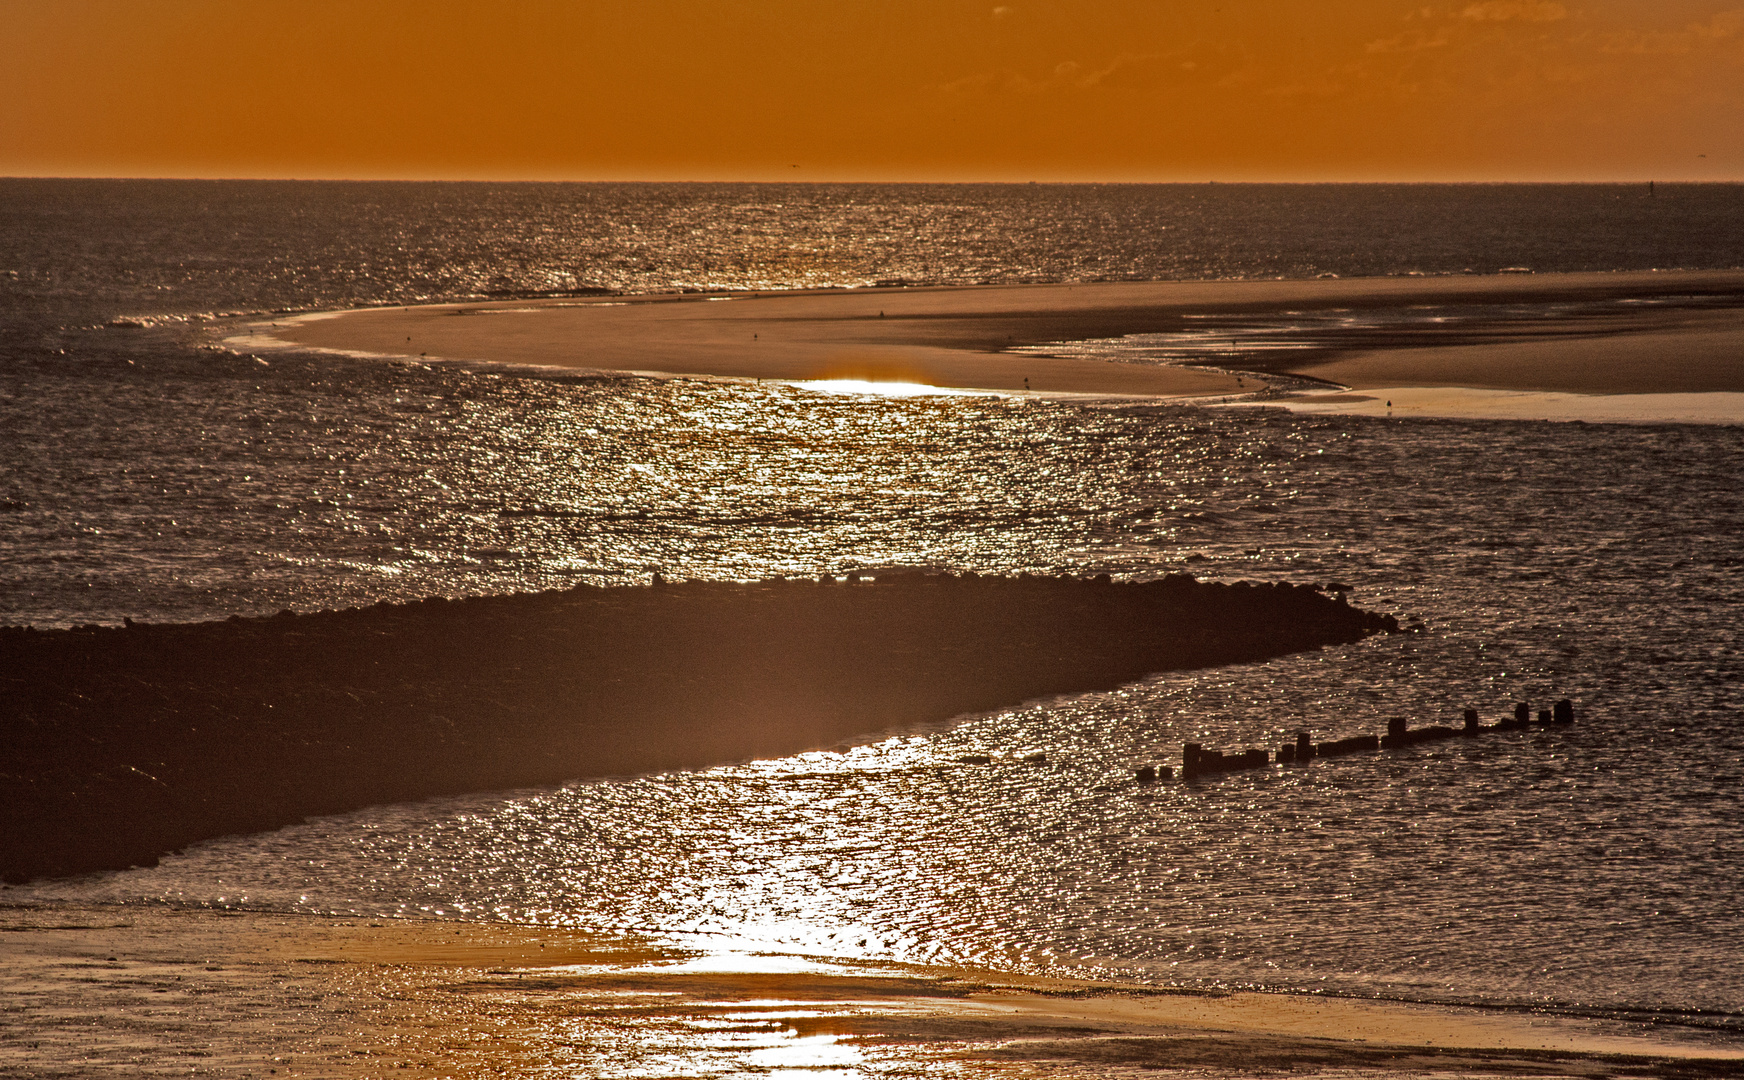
0, 0, 1744, 180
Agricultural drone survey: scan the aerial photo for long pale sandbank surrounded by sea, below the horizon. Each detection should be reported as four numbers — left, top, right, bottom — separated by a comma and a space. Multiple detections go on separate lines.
254, 270, 1744, 415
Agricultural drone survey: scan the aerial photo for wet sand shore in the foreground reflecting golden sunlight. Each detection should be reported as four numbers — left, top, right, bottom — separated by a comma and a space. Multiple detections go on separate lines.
0, 893, 1744, 1078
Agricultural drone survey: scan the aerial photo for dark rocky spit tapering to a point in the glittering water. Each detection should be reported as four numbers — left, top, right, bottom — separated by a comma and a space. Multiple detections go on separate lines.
0, 574, 1397, 883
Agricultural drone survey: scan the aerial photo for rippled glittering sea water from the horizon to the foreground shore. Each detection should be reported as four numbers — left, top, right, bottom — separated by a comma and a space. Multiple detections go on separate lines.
0, 181, 1744, 1029
